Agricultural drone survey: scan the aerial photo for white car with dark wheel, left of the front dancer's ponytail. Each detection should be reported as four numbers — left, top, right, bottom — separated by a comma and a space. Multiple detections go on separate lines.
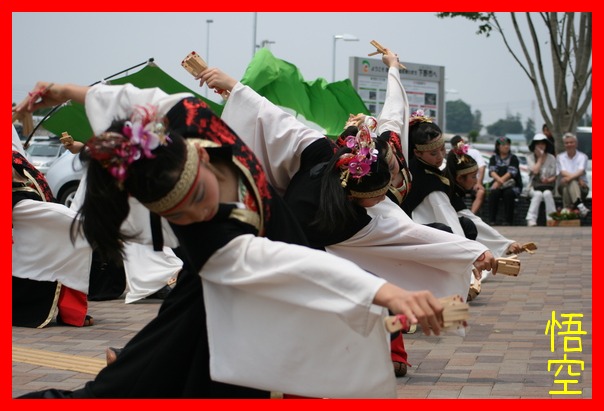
46, 151, 84, 207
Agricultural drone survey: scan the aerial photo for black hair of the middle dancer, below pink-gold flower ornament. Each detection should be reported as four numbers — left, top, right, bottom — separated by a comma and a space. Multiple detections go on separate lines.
311, 139, 391, 235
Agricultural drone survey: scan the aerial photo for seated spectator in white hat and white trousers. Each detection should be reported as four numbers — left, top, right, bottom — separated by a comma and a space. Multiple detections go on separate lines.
526, 133, 556, 227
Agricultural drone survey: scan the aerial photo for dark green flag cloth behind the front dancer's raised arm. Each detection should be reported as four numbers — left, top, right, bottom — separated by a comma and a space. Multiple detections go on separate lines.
42, 62, 224, 142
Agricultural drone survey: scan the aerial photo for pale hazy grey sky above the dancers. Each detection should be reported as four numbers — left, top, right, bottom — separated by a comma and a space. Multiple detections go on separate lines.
12, 12, 568, 131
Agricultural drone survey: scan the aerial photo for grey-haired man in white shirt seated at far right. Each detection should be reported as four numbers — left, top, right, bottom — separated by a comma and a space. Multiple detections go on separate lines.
556, 133, 590, 217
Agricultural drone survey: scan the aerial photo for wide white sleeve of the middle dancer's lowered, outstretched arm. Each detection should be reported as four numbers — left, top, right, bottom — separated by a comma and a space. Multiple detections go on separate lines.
327, 199, 487, 300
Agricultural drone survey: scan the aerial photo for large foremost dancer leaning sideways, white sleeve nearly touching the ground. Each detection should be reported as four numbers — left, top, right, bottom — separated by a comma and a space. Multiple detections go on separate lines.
17, 78, 442, 398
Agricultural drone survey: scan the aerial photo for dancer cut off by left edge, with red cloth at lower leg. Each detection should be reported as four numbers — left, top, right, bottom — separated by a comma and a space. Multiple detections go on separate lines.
12, 127, 94, 328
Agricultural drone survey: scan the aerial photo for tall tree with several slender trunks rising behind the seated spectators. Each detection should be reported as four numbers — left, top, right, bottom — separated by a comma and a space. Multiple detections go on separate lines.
437, 12, 592, 151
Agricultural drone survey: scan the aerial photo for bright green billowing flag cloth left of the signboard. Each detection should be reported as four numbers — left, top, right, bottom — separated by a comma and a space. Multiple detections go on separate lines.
241, 48, 371, 136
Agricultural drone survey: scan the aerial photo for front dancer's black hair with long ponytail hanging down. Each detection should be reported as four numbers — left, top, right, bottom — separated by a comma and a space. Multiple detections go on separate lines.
72, 121, 186, 263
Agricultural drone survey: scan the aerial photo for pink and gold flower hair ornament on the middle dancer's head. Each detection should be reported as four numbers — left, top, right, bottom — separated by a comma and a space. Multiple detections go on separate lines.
336, 124, 378, 188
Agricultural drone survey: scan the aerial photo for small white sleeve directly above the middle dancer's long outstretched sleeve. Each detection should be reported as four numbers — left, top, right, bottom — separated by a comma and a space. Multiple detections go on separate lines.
411, 191, 465, 237
